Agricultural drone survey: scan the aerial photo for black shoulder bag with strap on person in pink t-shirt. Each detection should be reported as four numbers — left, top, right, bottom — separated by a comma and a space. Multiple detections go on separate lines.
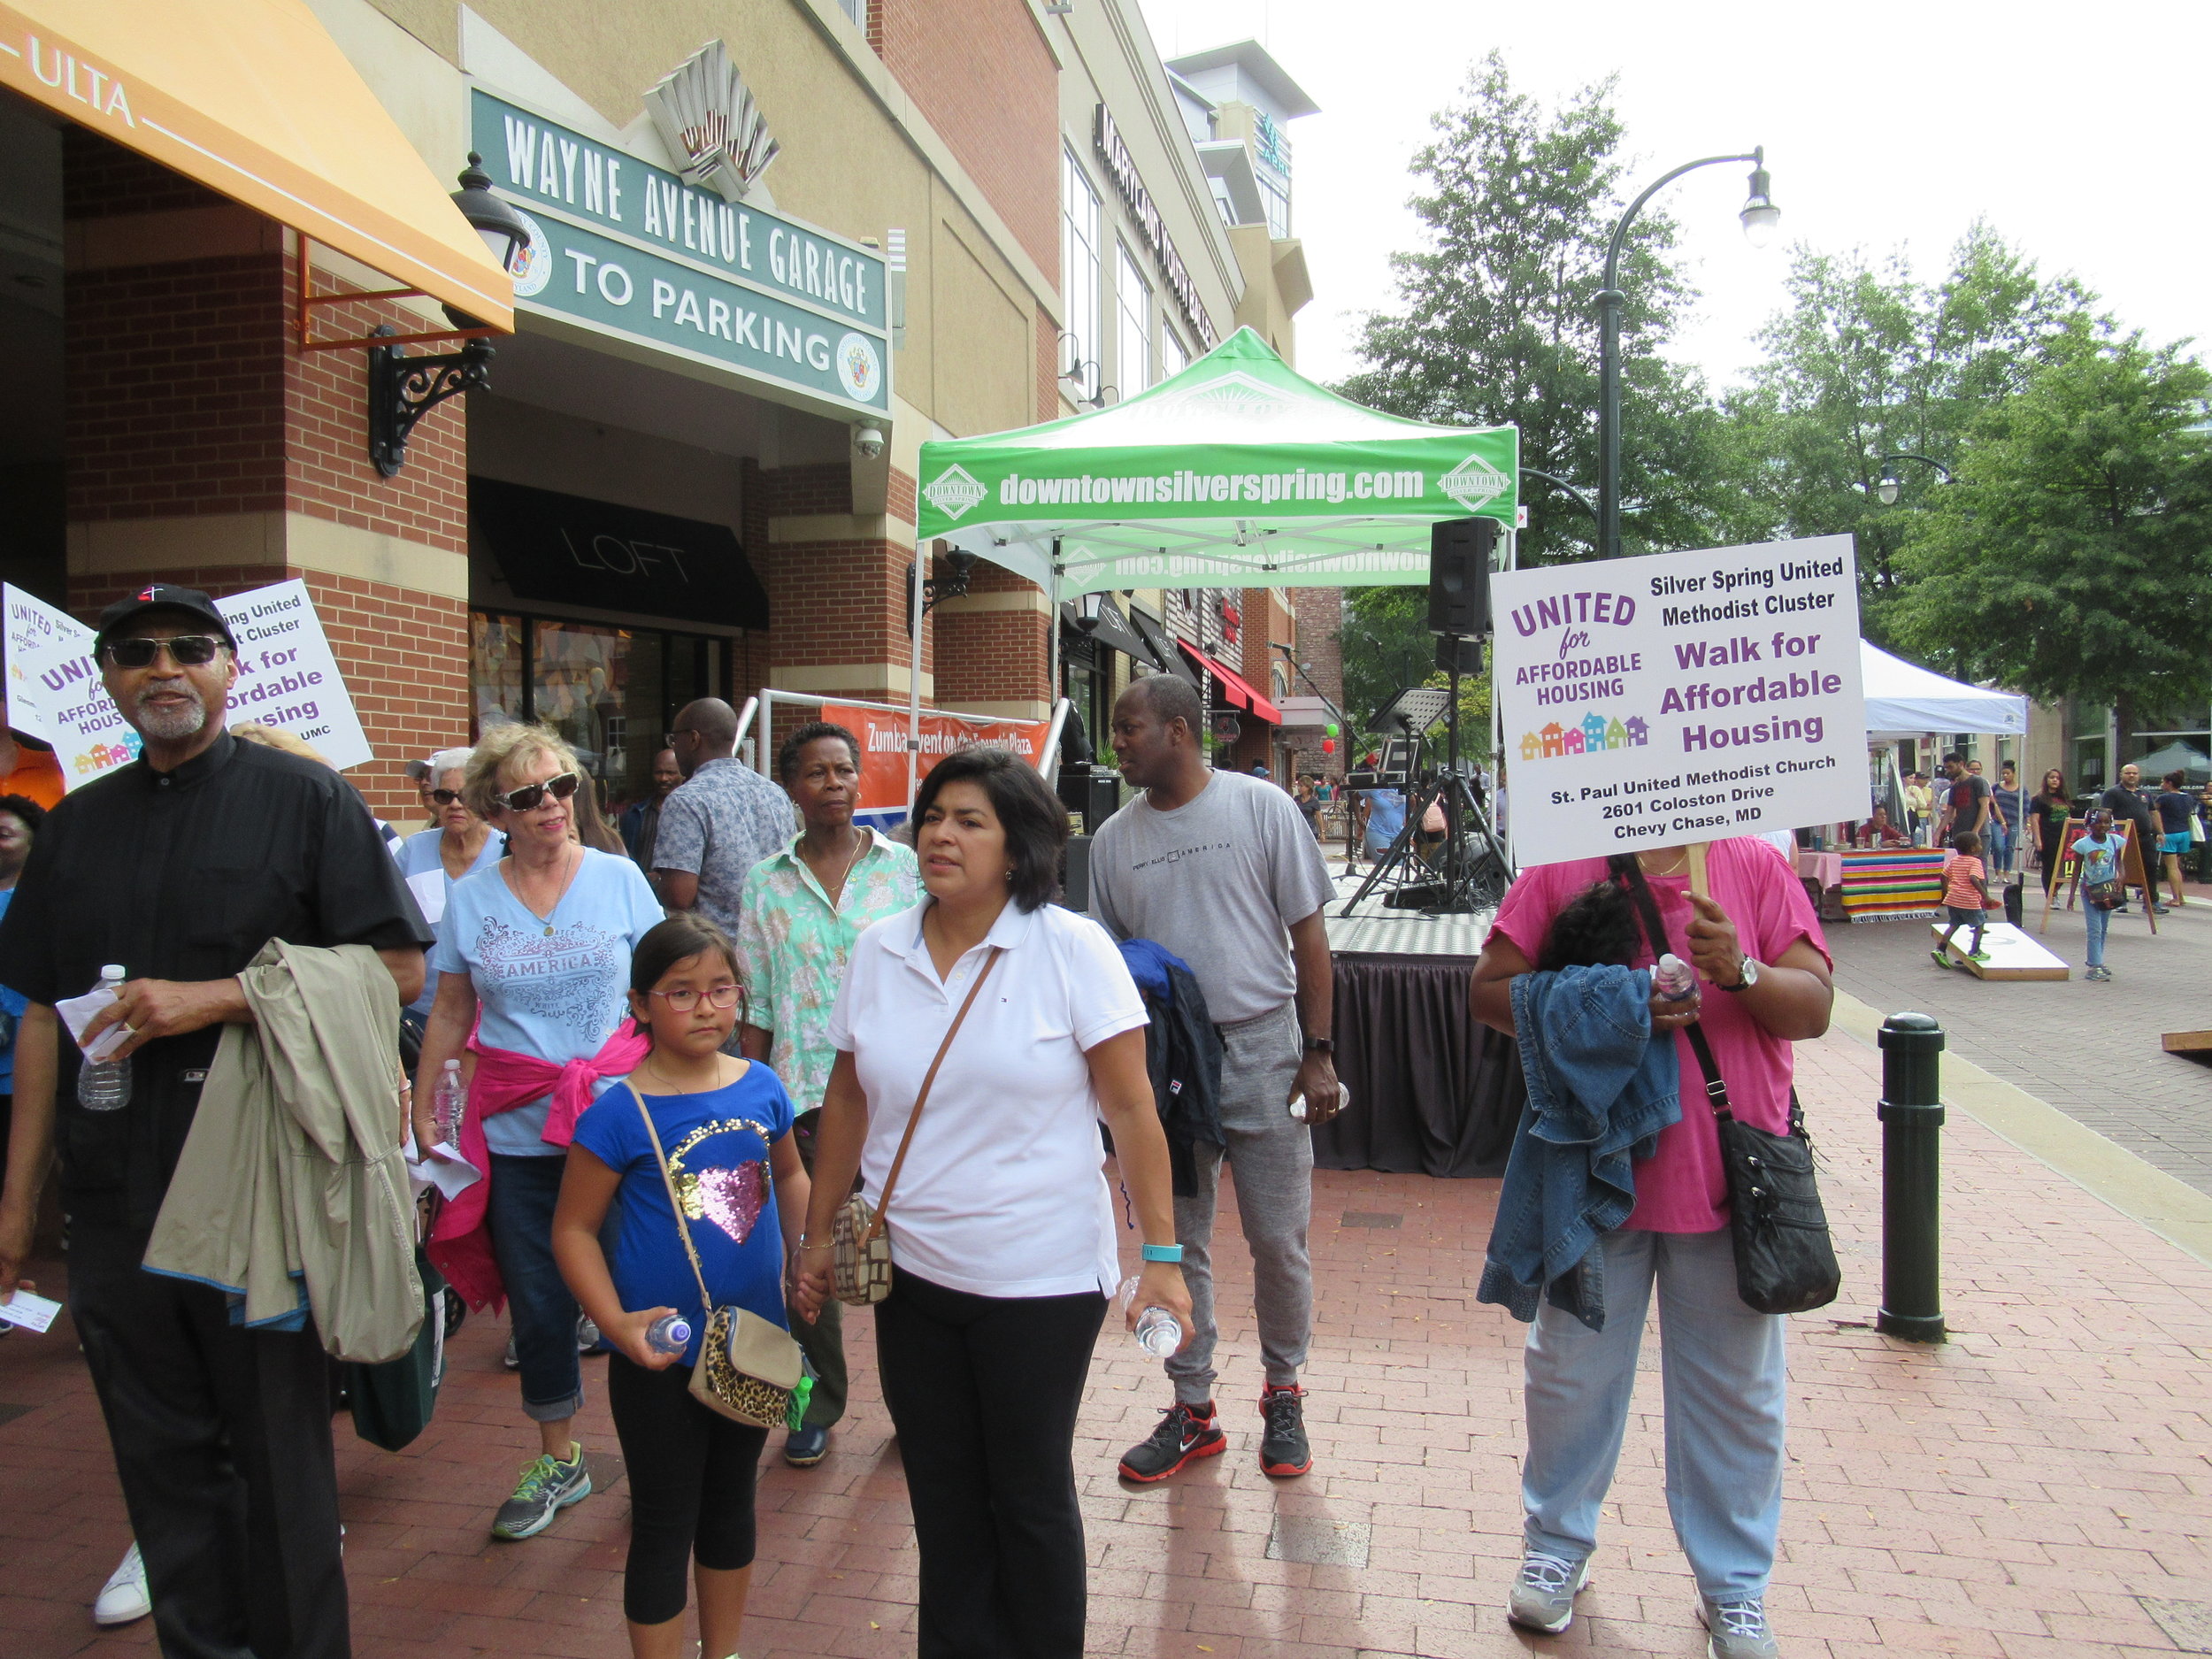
1610, 856, 1843, 1314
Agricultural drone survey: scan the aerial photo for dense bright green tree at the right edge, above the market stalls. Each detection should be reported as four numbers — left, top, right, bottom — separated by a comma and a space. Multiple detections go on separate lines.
1889, 319, 2212, 726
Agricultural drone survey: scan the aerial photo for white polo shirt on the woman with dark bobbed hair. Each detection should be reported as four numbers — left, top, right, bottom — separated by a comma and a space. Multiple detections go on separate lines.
830, 898, 1146, 1296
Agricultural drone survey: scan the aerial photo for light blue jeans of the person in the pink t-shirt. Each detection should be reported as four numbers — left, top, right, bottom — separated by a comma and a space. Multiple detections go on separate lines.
1522, 1228, 1787, 1601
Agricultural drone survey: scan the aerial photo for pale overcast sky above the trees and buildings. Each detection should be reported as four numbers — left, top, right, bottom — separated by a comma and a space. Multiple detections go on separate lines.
1144, 0, 2212, 398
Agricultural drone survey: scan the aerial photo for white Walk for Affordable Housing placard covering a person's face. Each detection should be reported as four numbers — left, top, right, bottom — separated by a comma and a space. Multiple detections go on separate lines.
1491, 535, 1867, 865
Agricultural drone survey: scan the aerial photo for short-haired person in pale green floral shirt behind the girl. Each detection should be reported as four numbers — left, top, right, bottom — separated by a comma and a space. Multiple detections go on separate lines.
737, 721, 920, 1469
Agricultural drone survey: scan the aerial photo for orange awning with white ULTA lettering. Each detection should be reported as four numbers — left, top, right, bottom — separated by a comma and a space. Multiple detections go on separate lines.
0, 0, 516, 332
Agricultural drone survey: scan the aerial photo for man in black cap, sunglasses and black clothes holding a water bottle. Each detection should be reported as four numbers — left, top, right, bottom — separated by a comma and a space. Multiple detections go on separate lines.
0, 582, 432, 1659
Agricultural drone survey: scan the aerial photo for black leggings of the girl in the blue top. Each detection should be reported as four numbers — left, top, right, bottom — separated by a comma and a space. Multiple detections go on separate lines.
606, 1354, 768, 1624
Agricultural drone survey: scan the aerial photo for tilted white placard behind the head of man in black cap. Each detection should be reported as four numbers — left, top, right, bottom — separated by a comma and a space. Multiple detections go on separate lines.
0, 580, 376, 790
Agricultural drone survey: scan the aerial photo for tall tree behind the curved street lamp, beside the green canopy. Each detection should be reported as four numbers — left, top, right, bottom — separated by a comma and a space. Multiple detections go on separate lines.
1339, 53, 1743, 565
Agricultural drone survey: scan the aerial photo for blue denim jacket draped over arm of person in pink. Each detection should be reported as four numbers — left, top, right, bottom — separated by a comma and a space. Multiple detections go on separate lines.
1476, 967, 1681, 1332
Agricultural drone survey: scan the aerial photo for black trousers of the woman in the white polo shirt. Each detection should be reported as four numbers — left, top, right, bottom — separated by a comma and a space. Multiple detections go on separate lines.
876, 1270, 1106, 1659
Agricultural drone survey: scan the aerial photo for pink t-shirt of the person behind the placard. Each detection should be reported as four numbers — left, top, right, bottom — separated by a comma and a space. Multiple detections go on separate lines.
1495, 836, 1834, 1233
